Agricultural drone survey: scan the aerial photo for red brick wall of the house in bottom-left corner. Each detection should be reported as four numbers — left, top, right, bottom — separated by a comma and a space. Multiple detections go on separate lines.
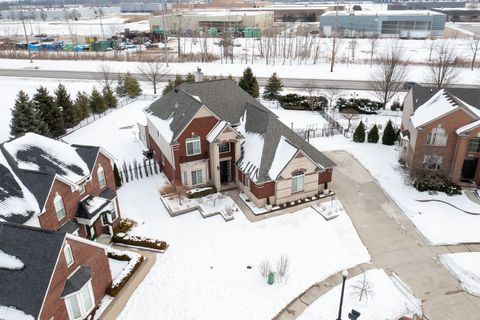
40, 239, 112, 320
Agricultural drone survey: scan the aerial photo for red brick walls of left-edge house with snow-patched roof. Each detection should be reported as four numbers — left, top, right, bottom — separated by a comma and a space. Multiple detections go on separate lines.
39, 153, 120, 236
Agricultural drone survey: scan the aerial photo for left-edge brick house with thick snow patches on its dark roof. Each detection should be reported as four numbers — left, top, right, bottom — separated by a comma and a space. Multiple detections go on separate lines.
0, 133, 120, 239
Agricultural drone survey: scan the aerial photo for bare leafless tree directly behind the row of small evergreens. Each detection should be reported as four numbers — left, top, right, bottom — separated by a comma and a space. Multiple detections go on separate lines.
371, 41, 408, 107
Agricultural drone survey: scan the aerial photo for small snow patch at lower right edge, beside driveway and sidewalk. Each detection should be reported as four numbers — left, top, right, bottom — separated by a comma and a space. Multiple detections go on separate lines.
439, 252, 480, 296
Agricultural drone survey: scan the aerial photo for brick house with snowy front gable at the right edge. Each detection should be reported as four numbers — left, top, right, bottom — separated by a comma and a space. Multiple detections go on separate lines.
400, 85, 480, 184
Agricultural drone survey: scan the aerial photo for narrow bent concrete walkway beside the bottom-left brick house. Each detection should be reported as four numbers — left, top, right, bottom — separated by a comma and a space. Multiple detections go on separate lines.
100, 246, 157, 320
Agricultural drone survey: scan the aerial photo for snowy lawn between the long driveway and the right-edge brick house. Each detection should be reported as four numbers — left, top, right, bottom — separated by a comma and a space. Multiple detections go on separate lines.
310, 135, 480, 245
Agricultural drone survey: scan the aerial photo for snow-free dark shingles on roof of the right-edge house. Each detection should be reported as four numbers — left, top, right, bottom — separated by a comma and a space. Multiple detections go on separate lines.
412, 84, 480, 111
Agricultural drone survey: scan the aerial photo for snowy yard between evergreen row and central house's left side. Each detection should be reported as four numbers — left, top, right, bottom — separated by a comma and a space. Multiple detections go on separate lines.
64, 100, 152, 164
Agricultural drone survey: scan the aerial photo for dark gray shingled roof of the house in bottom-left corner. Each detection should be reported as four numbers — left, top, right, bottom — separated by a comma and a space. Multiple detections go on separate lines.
0, 223, 65, 318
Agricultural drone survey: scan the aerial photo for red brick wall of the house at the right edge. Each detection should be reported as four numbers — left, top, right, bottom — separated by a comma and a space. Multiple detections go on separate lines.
409, 110, 474, 178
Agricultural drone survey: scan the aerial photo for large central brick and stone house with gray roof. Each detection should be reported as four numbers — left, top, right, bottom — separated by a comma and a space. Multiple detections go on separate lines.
142, 80, 335, 207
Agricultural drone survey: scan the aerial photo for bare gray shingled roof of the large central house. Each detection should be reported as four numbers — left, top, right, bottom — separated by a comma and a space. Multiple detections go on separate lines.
146, 79, 335, 183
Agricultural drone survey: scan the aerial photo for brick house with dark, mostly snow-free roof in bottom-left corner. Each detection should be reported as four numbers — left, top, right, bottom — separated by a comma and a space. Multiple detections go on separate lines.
0, 223, 112, 320
